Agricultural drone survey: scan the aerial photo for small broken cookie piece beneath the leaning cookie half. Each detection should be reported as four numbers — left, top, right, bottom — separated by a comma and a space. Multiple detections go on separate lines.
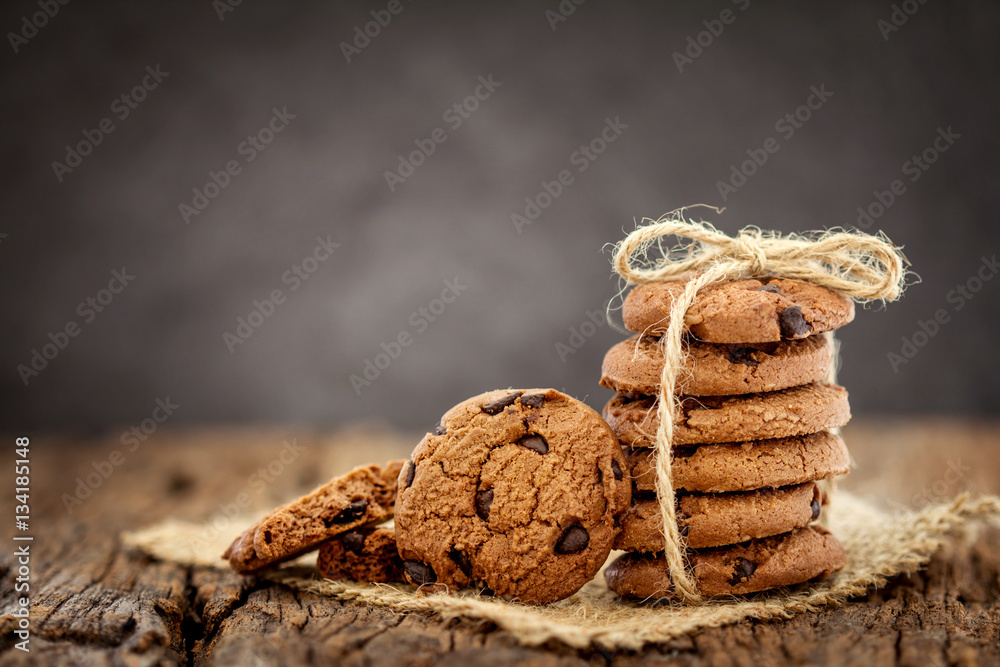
316, 527, 404, 583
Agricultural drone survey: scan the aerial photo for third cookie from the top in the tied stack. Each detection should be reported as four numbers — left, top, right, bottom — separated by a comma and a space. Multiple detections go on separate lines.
604, 382, 851, 447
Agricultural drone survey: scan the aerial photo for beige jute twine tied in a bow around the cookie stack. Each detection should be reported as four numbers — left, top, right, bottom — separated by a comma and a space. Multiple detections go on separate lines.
612, 204, 912, 604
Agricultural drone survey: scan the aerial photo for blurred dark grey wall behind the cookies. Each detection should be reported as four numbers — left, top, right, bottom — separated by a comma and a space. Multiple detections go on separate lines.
0, 0, 1000, 430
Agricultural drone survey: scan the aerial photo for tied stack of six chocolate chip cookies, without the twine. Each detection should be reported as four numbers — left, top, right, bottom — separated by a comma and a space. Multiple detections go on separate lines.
601, 277, 854, 599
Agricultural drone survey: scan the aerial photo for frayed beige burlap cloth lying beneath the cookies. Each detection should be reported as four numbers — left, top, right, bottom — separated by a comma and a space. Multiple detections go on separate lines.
122, 492, 1000, 649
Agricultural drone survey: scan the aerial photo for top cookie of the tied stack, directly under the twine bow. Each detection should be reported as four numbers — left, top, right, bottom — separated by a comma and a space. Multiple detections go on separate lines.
622, 276, 854, 343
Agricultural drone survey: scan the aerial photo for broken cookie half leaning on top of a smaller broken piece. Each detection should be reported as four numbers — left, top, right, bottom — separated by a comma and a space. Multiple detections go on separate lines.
222, 461, 403, 573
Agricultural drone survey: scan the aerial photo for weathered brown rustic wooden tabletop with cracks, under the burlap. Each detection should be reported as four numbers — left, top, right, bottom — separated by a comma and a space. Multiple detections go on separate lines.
0, 419, 1000, 665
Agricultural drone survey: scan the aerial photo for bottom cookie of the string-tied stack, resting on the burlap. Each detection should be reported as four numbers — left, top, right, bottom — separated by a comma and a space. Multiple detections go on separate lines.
604, 526, 847, 600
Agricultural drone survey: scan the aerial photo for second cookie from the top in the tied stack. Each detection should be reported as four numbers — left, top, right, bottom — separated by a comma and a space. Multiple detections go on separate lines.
601, 336, 833, 396
